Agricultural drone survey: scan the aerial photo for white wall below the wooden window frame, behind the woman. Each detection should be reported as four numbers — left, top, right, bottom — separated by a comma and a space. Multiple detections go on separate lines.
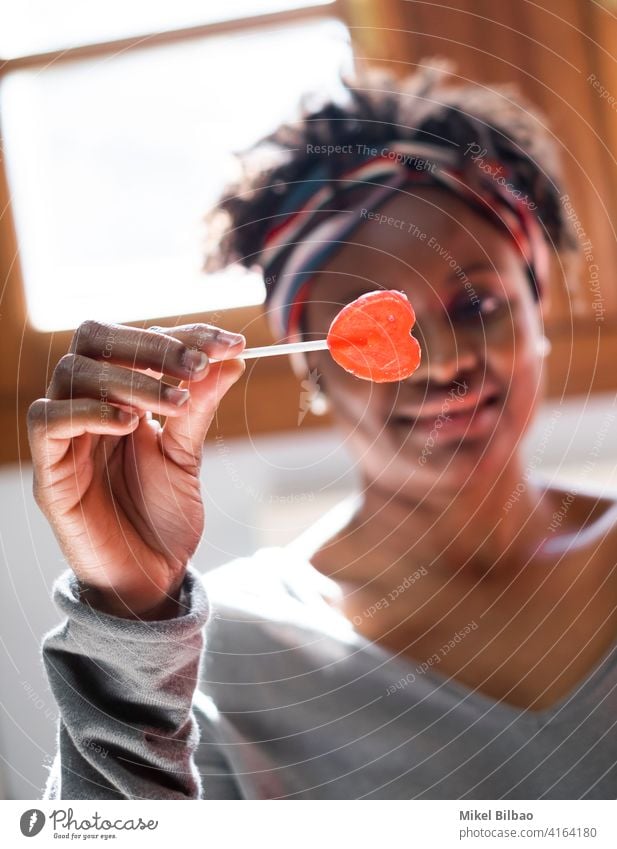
0, 395, 617, 799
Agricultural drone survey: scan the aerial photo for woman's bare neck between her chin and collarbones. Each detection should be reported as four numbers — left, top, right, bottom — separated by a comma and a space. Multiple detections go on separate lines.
315, 462, 552, 585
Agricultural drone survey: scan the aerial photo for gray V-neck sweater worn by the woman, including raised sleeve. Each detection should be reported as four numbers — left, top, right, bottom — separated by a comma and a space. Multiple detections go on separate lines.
42, 524, 617, 799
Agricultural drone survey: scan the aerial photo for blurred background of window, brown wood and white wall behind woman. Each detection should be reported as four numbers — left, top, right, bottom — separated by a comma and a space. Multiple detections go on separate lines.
0, 0, 617, 799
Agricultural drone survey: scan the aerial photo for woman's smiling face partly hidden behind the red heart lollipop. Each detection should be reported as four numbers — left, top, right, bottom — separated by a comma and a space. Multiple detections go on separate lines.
305, 188, 542, 495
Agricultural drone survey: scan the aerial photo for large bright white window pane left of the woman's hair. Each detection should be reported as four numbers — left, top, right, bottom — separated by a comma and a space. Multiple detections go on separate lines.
0, 19, 352, 331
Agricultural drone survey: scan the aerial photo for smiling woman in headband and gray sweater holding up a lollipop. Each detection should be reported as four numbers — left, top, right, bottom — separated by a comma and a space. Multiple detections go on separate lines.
30, 64, 617, 799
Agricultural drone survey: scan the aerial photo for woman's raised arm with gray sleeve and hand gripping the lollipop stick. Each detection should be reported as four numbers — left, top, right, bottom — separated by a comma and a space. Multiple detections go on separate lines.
28, 320, 246, 799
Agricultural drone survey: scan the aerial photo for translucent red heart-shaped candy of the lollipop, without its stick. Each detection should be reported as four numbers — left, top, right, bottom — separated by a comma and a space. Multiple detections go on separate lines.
327, 290, 421, 383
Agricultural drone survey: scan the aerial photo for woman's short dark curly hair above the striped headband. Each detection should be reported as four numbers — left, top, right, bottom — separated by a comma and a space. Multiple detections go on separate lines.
204, 59, 577, 271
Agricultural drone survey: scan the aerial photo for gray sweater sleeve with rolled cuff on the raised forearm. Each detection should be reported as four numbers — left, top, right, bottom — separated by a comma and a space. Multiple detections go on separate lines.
41, 565, 208, 799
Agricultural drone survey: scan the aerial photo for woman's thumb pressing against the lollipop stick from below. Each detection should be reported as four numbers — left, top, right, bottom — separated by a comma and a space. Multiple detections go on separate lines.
161, 359, 246, 473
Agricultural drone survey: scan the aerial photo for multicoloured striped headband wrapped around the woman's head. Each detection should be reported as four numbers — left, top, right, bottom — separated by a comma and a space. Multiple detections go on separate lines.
259, 141, 548, 341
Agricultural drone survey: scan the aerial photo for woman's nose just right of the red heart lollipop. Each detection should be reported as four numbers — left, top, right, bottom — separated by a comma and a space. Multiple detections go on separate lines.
410, 320, 478, 383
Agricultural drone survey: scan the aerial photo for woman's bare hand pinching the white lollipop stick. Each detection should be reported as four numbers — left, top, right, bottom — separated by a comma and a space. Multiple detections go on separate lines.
28, 321, 245, 619
